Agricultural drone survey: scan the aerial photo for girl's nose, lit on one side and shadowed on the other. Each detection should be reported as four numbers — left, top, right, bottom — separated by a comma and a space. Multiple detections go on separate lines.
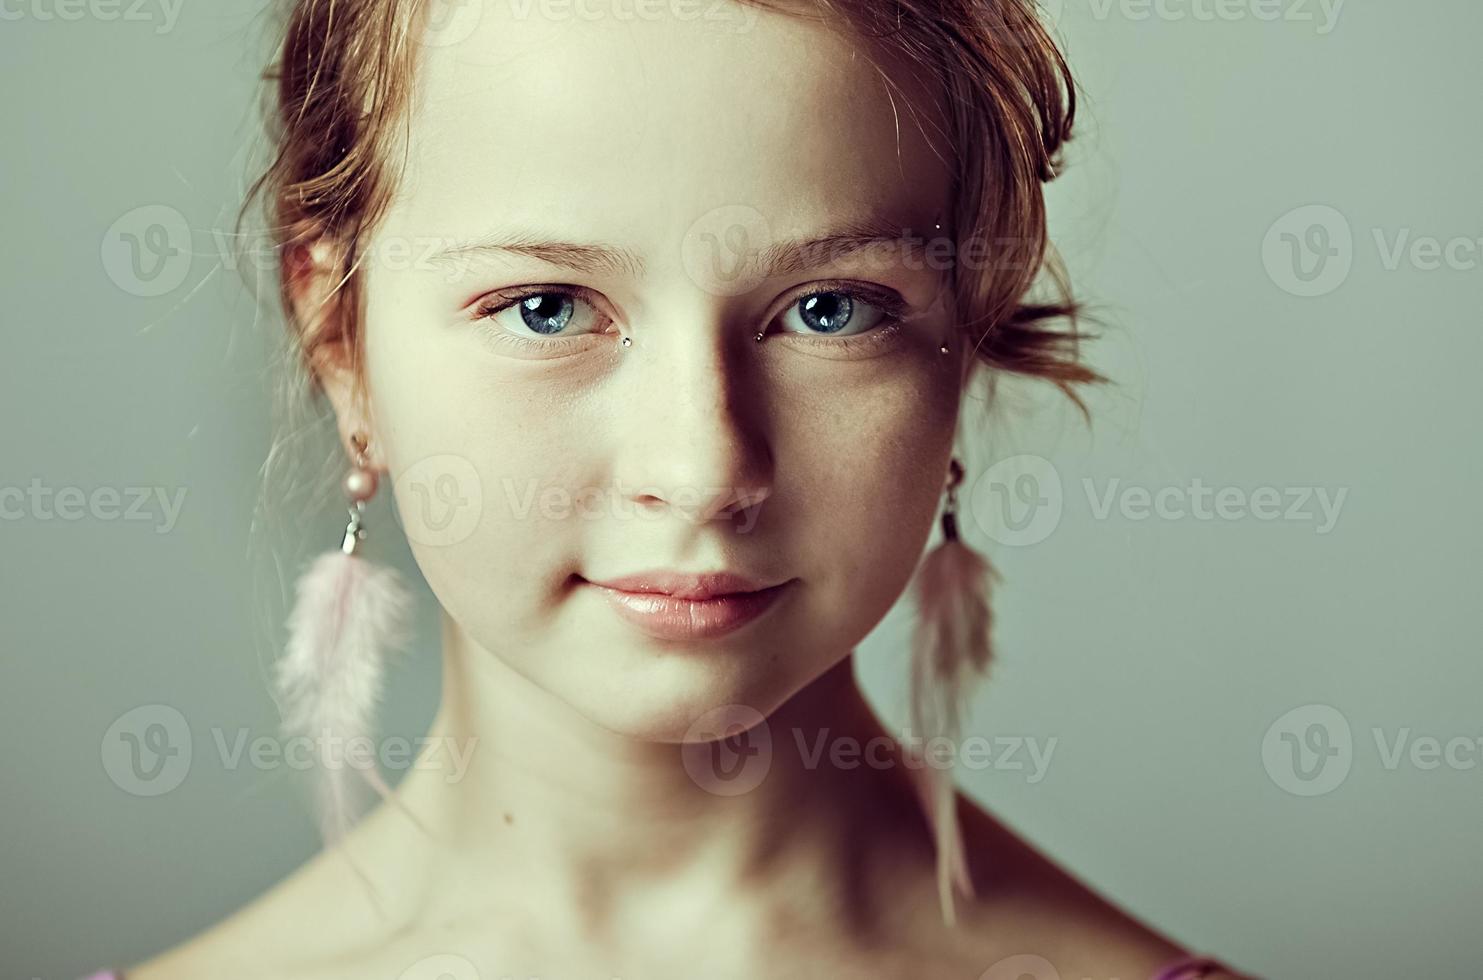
615, 320, 774, 523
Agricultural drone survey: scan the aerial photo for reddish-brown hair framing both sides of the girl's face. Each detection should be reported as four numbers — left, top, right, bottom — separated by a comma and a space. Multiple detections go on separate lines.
242, 0, 1105, 415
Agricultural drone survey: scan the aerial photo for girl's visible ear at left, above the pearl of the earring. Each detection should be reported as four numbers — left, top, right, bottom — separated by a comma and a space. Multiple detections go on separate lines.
283, 239, 383, 470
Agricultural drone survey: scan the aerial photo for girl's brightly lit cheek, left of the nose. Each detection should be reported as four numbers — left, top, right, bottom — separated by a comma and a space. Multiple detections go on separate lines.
366, 295, 601, 639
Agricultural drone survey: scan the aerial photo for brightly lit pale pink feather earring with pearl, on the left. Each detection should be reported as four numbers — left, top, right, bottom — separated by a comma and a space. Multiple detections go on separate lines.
276, 433, 415, 845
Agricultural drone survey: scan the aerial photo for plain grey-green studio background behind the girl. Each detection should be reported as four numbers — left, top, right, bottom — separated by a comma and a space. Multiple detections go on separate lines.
0, 0, 1483, 980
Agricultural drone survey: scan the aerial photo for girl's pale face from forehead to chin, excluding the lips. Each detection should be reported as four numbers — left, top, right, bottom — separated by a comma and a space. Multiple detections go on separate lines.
348, 0, 964, 740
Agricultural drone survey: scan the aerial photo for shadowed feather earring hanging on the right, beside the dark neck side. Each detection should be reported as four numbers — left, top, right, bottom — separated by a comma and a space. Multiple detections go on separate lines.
911, 458, 998, 925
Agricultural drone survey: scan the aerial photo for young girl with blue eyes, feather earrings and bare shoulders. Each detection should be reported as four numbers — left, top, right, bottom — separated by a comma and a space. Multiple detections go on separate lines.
86, 0, 1257, 980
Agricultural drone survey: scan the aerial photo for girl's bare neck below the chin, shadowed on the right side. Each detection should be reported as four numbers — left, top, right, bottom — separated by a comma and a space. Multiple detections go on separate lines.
356, 607, 930, 943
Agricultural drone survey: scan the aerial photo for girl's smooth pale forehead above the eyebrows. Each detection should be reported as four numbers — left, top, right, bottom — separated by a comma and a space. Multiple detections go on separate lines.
389, 0, 949, 245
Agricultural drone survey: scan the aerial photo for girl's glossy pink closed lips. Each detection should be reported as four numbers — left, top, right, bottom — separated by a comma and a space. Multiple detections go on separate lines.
587, 571, 793, 640
